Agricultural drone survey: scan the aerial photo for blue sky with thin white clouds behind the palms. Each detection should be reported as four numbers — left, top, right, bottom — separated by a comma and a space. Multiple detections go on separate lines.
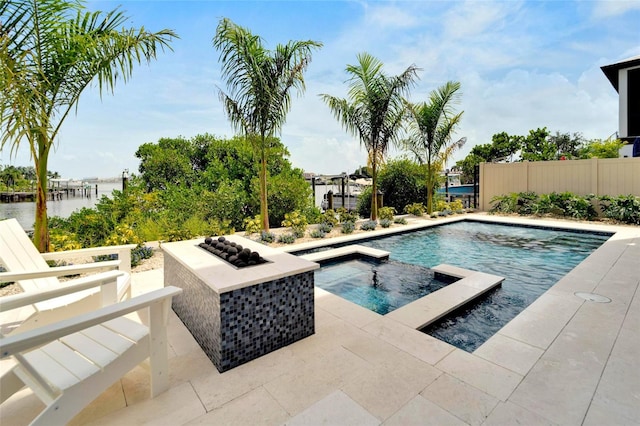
0, 0, 640, 179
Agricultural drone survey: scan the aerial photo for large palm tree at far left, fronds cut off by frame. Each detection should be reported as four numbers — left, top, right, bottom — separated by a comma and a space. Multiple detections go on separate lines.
0, 0, 177, 252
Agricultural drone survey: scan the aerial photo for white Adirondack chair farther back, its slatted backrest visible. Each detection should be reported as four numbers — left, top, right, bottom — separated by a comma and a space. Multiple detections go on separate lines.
0, 219, 135, 334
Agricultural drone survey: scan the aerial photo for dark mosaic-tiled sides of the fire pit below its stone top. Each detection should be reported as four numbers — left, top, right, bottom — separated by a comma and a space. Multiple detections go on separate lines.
164, 255, 315, 372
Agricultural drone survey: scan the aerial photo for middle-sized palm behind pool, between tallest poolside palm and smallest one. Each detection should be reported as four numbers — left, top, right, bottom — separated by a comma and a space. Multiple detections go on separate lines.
320, 52, 418, 220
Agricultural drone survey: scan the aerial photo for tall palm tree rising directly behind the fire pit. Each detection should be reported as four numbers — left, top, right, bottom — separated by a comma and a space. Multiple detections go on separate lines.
213, 18, 322, 231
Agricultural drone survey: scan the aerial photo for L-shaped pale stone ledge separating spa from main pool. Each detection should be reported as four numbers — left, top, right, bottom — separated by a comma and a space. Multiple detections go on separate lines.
386, 264, 504, 330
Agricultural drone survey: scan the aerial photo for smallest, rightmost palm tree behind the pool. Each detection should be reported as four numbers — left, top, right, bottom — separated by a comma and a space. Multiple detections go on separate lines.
403, 81, 467, 214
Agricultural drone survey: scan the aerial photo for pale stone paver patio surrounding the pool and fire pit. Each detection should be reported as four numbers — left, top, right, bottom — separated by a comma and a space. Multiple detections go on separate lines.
0, 214, 640, 425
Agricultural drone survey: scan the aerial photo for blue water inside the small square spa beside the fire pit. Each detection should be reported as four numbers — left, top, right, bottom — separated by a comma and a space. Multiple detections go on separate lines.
314, 259, 447, 315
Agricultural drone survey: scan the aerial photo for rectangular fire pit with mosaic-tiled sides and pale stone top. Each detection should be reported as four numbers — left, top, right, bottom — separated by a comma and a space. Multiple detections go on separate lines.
162, 235, 319, 372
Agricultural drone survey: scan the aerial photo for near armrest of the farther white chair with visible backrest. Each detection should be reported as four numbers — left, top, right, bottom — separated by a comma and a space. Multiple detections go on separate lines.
0, 271, 125, 312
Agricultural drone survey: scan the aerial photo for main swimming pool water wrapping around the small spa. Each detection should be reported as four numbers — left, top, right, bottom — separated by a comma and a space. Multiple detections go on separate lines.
310, 221, 610, 352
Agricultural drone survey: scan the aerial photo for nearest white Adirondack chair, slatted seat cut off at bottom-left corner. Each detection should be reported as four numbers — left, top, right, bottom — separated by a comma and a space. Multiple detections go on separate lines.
0, 280, 182, 425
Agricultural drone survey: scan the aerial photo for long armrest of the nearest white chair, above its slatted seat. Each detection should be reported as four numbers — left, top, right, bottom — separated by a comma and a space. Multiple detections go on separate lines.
0, 286, 182, 358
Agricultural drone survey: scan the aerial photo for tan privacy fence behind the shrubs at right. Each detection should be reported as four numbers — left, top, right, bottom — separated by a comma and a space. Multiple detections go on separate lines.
479, 158, 640, 211
